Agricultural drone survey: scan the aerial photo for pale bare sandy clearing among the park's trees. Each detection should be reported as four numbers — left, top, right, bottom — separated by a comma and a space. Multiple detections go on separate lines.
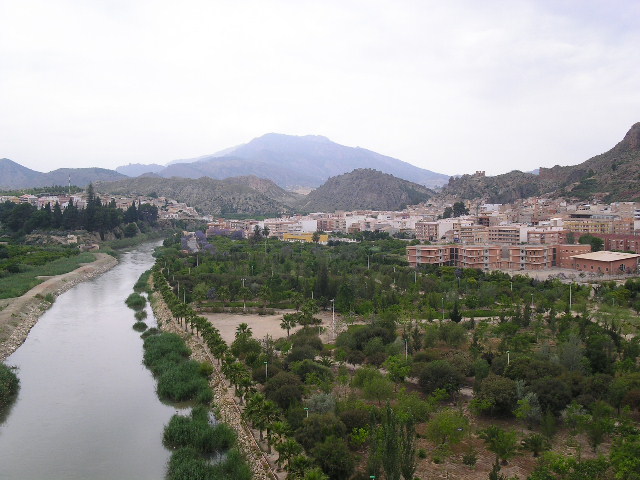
201, 310, 339, 345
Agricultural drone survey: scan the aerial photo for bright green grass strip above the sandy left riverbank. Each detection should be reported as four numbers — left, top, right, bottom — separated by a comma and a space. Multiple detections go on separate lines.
0, 252, 96, 298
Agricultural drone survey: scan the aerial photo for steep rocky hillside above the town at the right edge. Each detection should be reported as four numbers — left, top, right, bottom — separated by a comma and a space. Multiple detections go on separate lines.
443, 123, 640, 203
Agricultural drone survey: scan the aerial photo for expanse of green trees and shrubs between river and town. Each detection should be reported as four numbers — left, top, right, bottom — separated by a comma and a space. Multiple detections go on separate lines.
154, 231, 640, 480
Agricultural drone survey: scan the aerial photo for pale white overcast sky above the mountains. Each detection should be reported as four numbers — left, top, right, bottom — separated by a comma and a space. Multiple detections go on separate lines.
0, 0, 640, 174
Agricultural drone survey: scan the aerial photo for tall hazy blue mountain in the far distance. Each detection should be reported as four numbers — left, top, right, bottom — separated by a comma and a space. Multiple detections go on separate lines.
116, 133, 449, 190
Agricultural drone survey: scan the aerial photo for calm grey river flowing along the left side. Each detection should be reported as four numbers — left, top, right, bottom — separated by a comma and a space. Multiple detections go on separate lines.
0, 243, 175, 480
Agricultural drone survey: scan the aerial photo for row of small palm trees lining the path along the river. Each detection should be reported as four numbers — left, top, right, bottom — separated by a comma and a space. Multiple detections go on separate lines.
153, 263, 328, 480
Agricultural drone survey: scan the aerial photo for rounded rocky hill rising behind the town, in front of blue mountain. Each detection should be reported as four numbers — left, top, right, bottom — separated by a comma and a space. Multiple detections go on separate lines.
298, 168, 433, 212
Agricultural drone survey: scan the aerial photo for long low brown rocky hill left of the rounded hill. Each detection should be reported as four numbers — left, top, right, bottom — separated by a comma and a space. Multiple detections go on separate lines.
95, 177, 297, 215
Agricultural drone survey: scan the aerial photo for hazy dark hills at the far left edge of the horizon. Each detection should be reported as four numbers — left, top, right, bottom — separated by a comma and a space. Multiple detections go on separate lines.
0, 158, 125, 190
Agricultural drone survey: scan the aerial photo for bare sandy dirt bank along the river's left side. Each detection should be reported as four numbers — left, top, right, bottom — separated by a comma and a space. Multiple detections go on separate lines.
0, 253, 118, 361
